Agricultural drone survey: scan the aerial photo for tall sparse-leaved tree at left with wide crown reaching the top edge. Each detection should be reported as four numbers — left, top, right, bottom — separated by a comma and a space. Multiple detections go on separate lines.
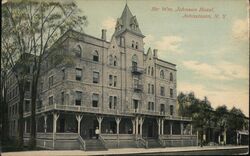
1, 0, 87, 148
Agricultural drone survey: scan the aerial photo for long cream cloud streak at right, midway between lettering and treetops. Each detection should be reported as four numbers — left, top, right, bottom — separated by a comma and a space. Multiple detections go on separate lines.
182, 60, 249, 80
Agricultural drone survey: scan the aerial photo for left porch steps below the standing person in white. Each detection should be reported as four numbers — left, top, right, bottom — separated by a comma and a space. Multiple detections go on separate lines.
85, 139, 107, 151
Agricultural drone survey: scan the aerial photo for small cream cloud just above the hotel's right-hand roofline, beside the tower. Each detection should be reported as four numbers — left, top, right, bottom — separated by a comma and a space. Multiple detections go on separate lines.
155, 36, 183, 53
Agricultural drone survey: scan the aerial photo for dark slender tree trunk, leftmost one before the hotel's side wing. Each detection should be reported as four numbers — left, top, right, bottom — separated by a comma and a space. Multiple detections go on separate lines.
18, 82, 25, 149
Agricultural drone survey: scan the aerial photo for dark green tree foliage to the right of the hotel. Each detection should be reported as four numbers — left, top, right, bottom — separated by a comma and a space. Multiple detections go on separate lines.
177, 92, 246, 141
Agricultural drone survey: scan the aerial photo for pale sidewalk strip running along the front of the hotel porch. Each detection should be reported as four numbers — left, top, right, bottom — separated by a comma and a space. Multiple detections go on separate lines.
2, 146, 249, 156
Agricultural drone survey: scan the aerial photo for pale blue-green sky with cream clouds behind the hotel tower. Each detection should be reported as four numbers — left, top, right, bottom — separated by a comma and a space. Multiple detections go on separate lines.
75, 0, 249, 117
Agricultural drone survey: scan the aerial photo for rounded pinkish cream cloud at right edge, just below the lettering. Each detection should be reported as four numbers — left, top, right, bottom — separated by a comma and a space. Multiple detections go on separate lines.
232, 19, 249, 41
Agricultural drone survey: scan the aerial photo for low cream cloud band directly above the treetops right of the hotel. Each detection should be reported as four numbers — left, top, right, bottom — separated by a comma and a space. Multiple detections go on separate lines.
178, 82, 249, 116
